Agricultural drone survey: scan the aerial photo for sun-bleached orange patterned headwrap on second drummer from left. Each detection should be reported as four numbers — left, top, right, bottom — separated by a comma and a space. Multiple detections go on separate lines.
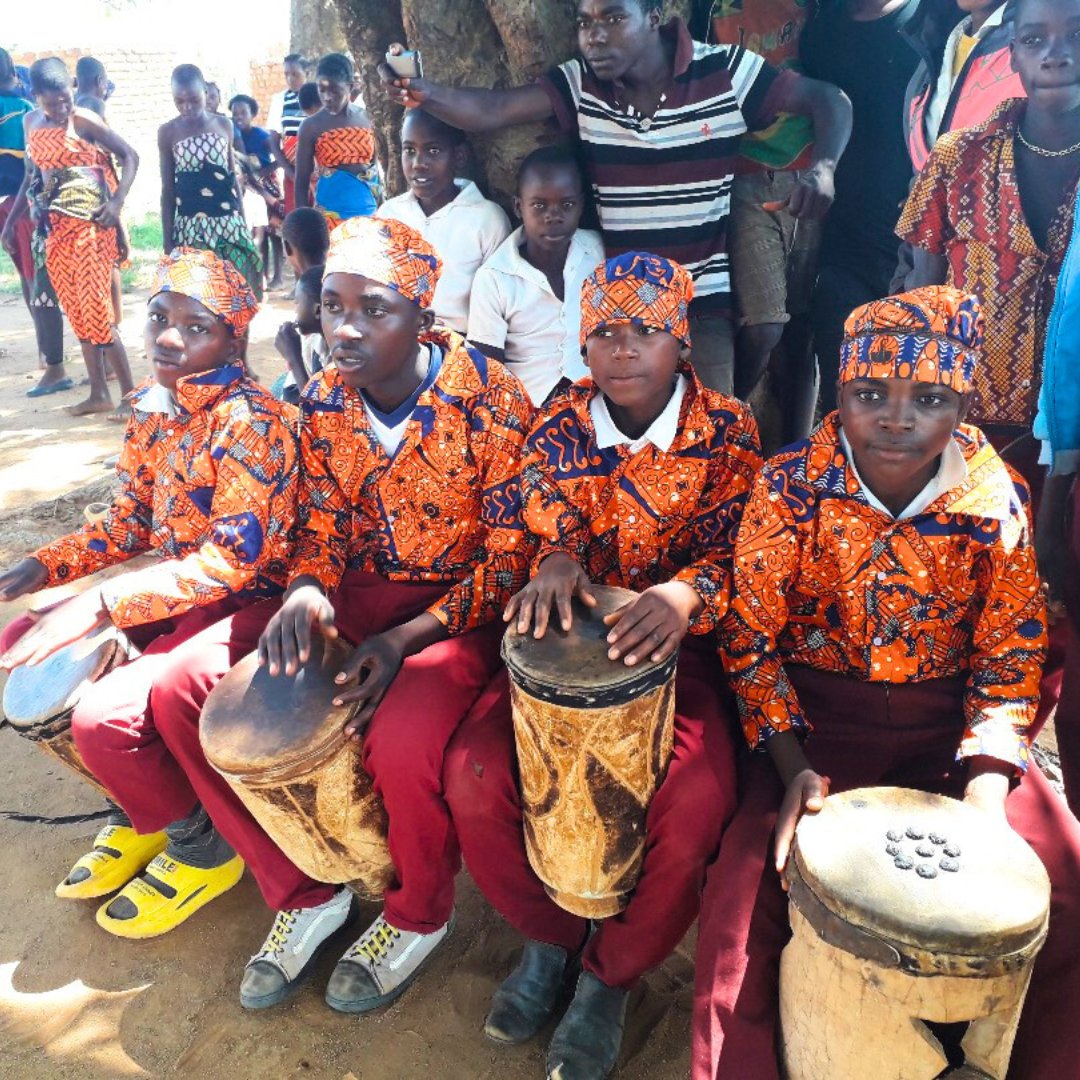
326, 217, 443, 308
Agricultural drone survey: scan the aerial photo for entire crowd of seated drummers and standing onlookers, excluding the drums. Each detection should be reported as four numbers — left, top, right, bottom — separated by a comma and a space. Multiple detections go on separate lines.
0, 0, 1080, 1080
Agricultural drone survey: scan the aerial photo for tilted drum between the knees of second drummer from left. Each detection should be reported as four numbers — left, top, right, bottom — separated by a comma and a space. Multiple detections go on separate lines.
199, 634, 394, 900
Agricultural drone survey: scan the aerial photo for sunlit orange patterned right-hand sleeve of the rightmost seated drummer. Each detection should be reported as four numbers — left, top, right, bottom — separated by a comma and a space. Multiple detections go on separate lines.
957, 522, 1047, 772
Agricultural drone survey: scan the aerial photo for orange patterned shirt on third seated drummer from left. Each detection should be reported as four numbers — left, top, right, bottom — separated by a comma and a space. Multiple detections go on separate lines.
522, 370, 761, 634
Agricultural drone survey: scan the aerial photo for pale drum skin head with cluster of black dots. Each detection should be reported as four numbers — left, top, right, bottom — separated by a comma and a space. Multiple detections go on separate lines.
794, 787, 1050, 956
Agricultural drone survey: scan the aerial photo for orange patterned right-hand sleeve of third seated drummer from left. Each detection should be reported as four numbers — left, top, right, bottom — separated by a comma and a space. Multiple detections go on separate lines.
673, 409, 761, 634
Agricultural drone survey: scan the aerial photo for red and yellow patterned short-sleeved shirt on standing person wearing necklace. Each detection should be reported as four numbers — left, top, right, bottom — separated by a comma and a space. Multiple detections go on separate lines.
896, 99, 1080, 428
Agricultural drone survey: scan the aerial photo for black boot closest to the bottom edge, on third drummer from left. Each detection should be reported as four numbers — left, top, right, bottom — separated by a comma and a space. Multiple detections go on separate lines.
548, 971, 627, 1080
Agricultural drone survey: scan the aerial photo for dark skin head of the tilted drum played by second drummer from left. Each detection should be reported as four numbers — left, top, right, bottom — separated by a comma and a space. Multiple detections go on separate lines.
199, 634, 355, 777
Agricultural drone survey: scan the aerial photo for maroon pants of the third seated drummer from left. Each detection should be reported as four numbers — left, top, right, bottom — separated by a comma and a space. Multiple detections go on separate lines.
445, 647, 735, 987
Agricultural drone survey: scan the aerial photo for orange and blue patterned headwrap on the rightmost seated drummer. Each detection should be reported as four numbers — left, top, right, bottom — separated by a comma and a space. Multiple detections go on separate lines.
840, 285, 983, 394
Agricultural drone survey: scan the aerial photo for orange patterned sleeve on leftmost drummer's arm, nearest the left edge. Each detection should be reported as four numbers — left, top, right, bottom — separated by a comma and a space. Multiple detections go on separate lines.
32, 415, 153, 586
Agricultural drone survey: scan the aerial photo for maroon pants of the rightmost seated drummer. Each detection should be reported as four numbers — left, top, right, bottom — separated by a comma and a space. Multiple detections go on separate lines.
692, 667, 1080, 1080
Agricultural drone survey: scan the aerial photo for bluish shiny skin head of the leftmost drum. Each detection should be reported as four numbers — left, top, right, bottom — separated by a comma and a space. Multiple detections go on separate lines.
3, 625, 121, 730
